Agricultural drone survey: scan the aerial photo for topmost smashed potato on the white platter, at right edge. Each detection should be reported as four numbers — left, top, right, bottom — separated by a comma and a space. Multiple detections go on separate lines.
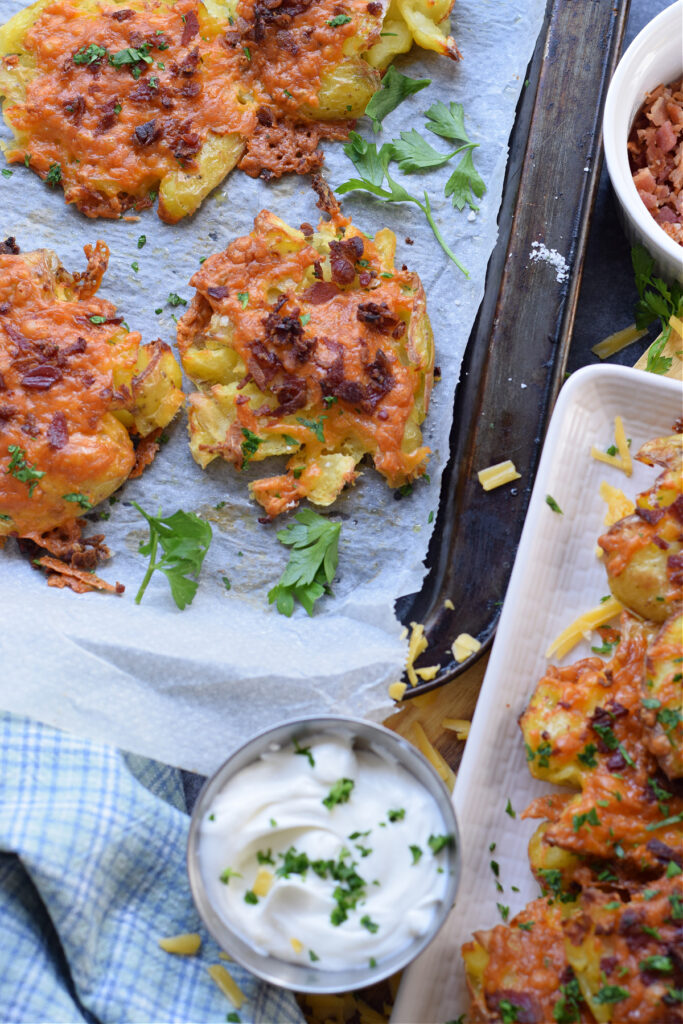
598, 434, 683, 623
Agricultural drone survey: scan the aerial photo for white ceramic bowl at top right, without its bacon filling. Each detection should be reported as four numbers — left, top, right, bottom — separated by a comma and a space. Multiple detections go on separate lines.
602, 0, 683, 282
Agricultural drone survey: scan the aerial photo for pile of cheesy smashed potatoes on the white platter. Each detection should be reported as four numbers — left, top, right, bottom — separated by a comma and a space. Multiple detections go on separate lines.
463, 434, 683, 1024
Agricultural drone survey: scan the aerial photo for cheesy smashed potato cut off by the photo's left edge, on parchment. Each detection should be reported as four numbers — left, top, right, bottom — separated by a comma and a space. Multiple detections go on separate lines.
0, 240, 183, 585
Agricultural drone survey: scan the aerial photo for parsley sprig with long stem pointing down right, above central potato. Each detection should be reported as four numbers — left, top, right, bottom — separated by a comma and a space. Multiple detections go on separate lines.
336, 131, 469, 278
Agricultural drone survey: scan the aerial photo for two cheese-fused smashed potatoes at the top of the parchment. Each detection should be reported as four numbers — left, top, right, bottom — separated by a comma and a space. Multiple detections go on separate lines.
0, 0, 460, 223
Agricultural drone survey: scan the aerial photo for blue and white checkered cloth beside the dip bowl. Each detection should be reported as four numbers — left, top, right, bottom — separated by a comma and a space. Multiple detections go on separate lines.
0, 715, 303, 1024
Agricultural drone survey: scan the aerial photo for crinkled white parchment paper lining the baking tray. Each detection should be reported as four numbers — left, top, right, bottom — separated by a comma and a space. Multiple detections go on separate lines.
0, 0, 545, 772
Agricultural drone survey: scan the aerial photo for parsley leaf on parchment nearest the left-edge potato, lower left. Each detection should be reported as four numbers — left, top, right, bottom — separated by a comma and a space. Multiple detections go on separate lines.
133, 502, 212, 610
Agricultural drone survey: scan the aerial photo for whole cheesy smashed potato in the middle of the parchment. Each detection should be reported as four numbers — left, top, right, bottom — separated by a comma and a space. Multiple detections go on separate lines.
178, 197, 434, 516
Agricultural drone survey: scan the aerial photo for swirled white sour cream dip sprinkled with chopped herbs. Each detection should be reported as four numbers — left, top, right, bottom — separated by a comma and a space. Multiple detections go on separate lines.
197, 734, 455, 971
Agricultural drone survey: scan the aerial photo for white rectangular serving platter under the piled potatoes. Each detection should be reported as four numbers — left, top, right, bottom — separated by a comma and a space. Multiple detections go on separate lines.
391, 366, 683, 1024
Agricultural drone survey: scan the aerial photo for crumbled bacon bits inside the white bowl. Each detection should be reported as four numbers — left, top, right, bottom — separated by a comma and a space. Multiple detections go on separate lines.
628, 79, 683, 246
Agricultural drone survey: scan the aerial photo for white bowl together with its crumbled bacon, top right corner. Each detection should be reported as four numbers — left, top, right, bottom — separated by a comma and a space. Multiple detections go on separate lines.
602, 0, 683, 281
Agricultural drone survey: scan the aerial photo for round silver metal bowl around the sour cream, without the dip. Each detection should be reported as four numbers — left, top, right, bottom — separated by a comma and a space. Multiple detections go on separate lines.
187, 716, 462, 992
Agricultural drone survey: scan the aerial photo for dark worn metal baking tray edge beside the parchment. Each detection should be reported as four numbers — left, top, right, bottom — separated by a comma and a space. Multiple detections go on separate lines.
396, 0, 629, 697
